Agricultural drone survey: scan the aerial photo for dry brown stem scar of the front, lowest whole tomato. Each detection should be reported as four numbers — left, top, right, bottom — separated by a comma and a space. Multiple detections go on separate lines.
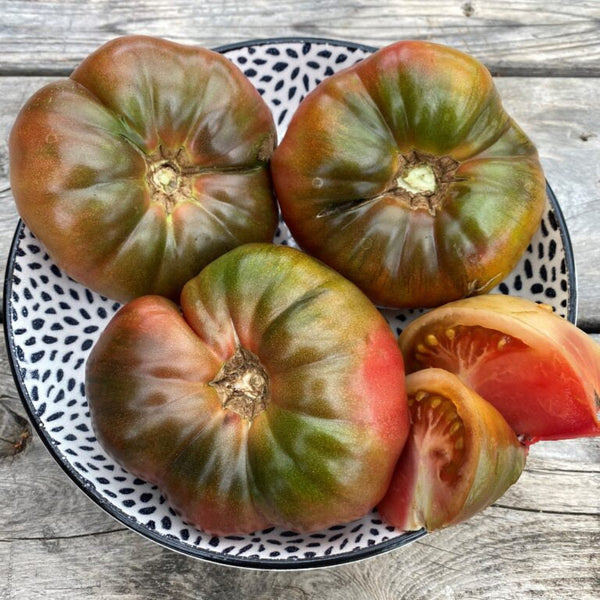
209, 346, 269, 422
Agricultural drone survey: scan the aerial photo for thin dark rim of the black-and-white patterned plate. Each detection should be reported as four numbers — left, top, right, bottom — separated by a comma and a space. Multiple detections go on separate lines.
2, 36, 577, 571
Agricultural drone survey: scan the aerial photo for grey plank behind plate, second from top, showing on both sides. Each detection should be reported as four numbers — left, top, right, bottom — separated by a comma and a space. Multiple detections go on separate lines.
0, 77, 600, 331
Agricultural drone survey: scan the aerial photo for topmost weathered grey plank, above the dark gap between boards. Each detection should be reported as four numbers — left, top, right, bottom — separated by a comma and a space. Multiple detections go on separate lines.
0, 0, 600, 76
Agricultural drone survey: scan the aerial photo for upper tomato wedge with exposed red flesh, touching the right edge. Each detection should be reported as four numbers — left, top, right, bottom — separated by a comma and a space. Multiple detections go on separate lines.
399, 294, 600, 442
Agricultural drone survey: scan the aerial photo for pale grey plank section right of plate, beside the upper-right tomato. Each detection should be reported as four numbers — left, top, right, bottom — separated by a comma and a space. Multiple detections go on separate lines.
496, 77, 600, 331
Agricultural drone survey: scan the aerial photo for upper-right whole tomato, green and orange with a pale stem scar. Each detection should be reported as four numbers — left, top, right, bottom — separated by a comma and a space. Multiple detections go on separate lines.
272, 41, 546, 307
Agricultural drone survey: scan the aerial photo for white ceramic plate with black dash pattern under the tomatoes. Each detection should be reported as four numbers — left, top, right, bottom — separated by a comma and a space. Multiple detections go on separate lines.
4, 39, 576, 569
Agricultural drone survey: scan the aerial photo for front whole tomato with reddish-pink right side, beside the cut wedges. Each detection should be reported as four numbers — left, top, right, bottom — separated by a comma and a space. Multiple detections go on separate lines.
86, 244, 409, 534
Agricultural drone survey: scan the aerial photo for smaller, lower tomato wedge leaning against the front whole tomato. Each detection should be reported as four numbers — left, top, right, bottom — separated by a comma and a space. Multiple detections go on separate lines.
378, 368, 527, 531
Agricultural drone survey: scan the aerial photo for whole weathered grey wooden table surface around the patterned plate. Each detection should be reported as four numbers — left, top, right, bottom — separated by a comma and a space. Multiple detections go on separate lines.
0, 0, 600, 600
